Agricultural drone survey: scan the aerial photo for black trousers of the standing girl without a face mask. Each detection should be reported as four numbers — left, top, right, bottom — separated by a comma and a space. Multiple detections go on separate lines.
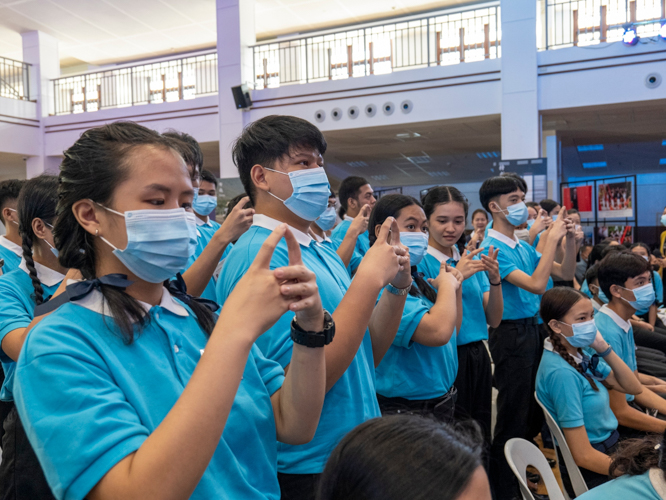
455, 340, 493, 465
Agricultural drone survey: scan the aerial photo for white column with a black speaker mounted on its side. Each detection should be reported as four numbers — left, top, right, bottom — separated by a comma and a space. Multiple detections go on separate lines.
216, 0, 256, 179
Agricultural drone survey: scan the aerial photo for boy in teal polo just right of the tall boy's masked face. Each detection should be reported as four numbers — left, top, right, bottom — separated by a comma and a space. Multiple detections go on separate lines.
331, 176, 377, 274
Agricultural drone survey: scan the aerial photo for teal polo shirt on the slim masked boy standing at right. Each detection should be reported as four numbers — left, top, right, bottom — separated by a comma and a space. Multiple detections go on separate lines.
481, 229, 541, 320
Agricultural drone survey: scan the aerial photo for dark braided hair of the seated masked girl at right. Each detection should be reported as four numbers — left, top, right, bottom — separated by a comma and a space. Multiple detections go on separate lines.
539, 286, 599, 391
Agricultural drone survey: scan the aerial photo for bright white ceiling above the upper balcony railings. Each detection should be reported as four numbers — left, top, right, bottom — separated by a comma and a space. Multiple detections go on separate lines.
0, 0, 469, 71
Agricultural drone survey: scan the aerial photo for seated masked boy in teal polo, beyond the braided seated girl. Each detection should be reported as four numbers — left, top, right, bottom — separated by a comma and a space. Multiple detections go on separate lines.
594, 251, 666, 436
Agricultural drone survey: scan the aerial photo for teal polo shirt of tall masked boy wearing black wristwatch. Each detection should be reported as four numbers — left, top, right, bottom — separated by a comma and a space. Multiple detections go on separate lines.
217, 214, 380, 474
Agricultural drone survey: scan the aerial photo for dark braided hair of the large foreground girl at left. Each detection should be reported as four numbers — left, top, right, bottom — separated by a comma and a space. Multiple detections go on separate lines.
54, 122, 215, 344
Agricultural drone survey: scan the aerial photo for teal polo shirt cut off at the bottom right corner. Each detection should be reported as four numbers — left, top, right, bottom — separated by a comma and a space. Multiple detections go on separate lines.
578, 469, 666, 500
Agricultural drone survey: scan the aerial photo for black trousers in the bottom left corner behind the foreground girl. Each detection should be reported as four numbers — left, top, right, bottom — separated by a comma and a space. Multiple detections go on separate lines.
0, 407, 55, 500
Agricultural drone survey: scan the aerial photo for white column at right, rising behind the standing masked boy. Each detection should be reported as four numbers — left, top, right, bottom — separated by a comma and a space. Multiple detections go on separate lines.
501, 0, 541, 160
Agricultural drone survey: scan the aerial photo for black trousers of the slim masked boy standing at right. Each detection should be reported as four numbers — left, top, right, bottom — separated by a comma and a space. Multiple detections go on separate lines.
488, 318, 546, 500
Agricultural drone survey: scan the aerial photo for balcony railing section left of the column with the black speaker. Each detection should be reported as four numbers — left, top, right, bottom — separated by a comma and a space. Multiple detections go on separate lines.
52, 52, 217, 115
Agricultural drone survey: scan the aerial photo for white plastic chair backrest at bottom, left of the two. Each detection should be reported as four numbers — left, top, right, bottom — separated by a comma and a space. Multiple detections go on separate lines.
504, 438, 564, 500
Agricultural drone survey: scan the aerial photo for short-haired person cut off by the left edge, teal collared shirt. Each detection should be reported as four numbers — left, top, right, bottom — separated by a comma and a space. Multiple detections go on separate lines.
0, 179, 25, 275
